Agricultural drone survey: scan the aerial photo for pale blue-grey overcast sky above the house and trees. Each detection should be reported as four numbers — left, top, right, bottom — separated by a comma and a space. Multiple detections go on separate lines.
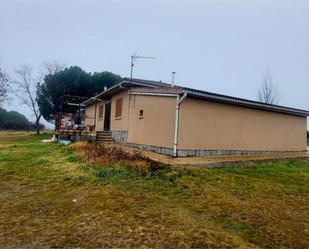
0, 0, 309, 128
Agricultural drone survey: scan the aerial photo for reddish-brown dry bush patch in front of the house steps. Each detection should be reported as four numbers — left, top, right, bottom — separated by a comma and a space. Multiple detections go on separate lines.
71, 142, 166, 175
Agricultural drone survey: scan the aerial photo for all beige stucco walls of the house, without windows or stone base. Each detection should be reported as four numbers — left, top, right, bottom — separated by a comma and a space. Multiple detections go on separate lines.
86, 90, 307, 151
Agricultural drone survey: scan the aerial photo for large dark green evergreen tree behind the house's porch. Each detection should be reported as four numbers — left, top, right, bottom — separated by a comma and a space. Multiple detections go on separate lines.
37, 66, 121, 121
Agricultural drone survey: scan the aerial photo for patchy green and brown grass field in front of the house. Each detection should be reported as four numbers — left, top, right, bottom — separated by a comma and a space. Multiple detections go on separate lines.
0, 132, 309, 248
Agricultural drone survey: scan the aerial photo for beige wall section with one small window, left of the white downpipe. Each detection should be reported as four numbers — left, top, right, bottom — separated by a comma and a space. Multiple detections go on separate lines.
128, 95, 176, 148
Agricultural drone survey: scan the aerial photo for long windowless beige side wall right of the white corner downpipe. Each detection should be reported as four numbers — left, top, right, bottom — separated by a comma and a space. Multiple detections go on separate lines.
179, 98, 307, 151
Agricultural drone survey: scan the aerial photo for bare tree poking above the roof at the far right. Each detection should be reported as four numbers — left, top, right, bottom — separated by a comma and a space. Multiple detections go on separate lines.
257, 69, 280, 105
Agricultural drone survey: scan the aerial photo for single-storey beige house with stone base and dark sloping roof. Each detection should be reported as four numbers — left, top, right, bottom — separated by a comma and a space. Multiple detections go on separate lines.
84, 78, 309, 156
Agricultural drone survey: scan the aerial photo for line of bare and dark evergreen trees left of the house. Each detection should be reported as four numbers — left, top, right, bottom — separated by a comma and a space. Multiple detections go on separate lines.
0, 61, 122, 133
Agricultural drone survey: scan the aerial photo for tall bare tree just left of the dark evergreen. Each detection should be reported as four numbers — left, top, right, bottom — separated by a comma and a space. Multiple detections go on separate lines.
13, 66, 42, 134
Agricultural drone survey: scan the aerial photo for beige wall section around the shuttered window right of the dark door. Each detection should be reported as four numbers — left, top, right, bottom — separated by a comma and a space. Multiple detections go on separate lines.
111, 90, 129, 131
